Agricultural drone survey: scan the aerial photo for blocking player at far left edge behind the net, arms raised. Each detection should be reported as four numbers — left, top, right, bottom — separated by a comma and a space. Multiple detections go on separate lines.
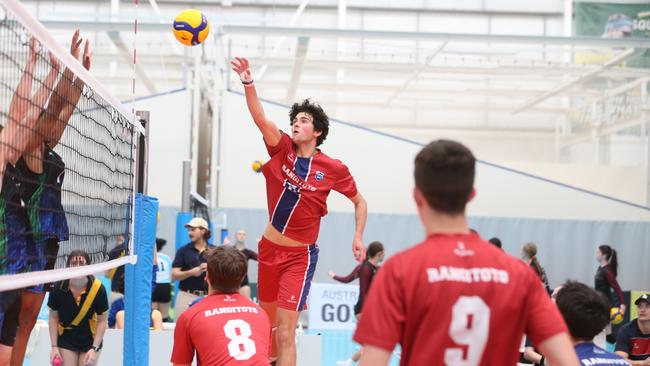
0, 38, 59, 359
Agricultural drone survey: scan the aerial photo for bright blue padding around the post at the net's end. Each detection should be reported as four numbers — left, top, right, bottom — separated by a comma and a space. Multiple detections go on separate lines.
124, 193, 159, 366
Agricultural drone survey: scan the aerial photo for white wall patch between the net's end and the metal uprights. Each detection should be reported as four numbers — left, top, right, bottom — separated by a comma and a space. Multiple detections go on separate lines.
136, 90, 191, 207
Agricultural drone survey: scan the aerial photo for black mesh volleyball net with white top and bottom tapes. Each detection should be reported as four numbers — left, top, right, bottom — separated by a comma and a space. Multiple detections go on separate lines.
0, 0, 143, 291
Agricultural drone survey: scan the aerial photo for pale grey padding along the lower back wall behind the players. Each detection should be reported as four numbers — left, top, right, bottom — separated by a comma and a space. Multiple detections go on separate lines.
218, 208, 650, 290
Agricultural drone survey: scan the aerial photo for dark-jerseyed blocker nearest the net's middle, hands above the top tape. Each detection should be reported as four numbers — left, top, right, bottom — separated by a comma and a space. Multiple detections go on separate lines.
11, 30, 91, 366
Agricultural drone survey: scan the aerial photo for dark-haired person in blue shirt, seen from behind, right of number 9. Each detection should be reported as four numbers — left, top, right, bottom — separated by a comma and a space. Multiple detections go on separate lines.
555, 281, 629, 366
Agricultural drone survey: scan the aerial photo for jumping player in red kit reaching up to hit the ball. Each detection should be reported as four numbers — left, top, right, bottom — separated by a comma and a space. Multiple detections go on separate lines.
231, 58, 367, 366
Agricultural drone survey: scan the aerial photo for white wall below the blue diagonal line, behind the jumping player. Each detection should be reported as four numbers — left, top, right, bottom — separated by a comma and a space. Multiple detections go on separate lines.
218, 93, 650, 221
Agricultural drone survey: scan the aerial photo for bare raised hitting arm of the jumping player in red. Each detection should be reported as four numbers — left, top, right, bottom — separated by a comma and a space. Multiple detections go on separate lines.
230, 57, 282, 146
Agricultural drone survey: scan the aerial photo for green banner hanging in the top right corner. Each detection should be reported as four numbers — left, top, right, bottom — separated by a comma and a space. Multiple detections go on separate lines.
574, 2, 650, 68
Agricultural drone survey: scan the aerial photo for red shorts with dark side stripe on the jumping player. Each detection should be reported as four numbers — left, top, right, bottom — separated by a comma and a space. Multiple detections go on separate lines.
257, 237, 319, 311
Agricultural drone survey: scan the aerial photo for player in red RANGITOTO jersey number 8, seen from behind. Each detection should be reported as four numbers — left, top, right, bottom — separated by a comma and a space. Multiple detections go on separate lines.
171, 245, 271, 366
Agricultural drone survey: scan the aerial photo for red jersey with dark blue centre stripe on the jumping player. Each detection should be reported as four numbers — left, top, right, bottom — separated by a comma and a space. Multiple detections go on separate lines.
262, 132, 357, 243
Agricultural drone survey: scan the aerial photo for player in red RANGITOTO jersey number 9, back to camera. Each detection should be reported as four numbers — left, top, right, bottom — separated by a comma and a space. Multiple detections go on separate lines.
354, 140, 578, 366
